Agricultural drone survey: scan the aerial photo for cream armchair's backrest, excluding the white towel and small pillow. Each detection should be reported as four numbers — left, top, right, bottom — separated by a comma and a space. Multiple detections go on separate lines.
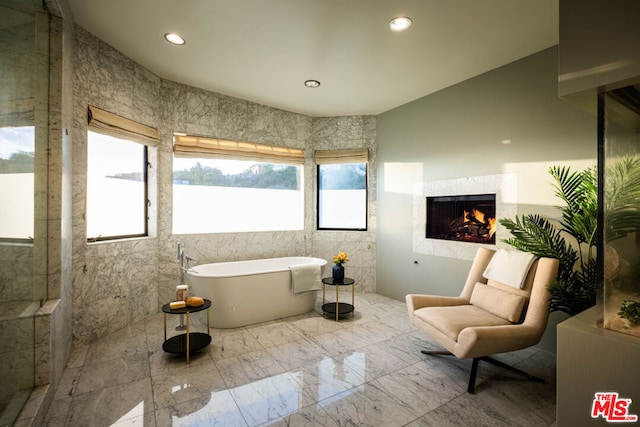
460, 247, 559, 332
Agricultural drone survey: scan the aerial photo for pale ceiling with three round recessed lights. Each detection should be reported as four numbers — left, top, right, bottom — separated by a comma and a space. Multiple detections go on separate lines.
68, 0, 558, 117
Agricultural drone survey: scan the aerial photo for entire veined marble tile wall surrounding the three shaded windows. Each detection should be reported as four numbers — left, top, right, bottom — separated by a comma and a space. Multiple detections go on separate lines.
73, 27, 376, 343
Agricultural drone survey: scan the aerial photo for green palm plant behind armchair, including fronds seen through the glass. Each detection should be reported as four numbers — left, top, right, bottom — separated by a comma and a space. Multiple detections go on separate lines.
500, 158, 640, 316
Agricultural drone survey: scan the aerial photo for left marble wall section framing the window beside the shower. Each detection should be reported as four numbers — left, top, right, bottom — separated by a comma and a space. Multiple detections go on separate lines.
71, 26, 160, 343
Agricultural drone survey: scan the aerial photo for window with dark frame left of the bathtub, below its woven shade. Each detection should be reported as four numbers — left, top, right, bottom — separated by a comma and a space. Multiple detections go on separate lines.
86, 131, 147, 241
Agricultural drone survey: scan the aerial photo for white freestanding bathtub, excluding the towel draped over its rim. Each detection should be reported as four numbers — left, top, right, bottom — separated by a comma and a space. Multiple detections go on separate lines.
187, 257, 327, 328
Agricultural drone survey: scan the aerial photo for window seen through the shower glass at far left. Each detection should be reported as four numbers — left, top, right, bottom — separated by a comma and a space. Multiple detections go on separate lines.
0, 126, 35, 242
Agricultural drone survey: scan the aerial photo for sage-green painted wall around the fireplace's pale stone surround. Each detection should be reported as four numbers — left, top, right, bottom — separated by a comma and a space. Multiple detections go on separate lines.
376, 47, 597, 350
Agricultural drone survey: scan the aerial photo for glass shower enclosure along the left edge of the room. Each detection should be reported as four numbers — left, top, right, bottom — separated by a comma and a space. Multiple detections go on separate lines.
0, 0, 49, 425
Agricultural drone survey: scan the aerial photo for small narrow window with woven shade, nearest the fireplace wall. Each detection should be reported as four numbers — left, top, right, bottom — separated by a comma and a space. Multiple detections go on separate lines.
315, 149, 368, 230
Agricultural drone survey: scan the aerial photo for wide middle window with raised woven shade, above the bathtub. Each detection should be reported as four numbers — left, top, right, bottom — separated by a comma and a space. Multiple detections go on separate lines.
173, 136, 304, 234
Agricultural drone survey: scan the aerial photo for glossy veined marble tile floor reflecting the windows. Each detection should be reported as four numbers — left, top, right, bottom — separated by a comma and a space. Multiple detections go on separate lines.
45, 294, 556, 427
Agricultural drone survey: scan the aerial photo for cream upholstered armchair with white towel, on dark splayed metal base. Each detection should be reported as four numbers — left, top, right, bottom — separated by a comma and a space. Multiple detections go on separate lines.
406, 248, 558, 393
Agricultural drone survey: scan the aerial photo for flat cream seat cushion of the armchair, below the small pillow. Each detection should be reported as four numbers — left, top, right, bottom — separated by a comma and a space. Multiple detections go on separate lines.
413, 305, 511, 342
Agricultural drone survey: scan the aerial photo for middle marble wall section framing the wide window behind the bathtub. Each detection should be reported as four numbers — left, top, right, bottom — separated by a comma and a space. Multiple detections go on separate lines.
158, 80, 313, 305
